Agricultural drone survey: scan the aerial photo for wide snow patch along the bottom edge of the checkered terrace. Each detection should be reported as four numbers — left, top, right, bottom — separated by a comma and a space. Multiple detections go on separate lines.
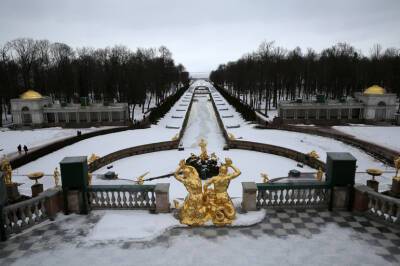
11, 221, 395, 266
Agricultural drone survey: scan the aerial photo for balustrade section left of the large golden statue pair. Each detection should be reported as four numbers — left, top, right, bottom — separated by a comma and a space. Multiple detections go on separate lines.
88, 185, 156, 210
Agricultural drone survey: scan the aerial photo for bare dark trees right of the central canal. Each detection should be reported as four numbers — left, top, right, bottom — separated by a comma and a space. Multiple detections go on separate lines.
210, 42, 400, 112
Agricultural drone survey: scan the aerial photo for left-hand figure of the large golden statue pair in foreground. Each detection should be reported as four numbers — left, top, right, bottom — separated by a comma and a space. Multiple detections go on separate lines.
174, 160, 209, 226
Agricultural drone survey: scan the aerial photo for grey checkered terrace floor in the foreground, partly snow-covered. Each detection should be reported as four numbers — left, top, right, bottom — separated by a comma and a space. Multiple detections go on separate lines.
0, 210, 400, 266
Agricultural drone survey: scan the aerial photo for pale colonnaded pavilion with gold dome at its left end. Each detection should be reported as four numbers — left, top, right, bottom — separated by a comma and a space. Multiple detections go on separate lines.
11, 90, 129, 127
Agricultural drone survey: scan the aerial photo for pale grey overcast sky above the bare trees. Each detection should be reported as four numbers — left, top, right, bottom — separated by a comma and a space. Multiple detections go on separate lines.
0, 0, 400, 75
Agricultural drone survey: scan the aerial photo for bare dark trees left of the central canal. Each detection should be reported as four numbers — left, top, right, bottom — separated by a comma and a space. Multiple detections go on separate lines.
0, 38, 189, 126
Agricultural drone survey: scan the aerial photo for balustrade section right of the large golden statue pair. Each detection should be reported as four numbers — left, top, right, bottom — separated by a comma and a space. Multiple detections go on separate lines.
256, 183, 331, 208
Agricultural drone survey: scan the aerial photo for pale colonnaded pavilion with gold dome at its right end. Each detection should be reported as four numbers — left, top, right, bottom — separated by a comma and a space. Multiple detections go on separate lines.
278, 85, 397, 123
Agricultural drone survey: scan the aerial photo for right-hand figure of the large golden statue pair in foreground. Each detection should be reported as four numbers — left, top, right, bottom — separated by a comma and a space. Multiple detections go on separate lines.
204, 158, 241, 225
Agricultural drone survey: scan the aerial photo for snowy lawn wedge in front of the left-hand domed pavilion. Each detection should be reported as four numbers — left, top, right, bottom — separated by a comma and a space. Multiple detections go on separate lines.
0, 127, 118, 157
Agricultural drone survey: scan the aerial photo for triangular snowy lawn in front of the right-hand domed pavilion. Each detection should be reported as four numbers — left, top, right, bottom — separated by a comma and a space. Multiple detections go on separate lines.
333, 125, 400, 153
